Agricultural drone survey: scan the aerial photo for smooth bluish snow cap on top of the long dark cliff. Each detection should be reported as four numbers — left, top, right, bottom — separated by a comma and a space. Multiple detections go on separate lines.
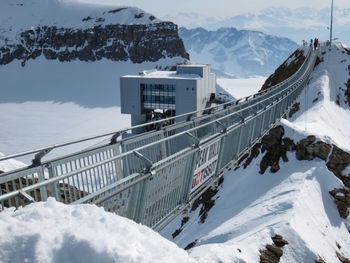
0, 0, 160, 44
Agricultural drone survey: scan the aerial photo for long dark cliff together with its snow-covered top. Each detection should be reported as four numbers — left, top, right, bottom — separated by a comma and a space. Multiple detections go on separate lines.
0, 0, 188, 66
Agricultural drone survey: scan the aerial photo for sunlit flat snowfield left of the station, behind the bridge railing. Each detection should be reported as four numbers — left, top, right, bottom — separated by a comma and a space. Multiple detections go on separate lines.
0, 101, 130, 164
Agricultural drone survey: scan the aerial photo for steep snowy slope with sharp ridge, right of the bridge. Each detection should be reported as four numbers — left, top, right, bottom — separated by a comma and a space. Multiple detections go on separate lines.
163, 42, 350, 262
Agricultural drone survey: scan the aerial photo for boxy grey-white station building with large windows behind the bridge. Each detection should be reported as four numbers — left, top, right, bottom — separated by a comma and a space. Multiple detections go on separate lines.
120, 65, 216, 132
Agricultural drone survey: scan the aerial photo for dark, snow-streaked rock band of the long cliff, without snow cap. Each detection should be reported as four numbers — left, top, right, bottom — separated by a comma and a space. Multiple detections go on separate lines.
0, 22, 189, 66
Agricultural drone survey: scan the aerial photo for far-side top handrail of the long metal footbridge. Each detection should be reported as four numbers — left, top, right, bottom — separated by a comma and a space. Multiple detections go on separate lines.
0, 46, 312, 162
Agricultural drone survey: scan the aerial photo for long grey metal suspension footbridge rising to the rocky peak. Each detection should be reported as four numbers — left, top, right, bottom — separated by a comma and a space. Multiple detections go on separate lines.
0, 48, 317, 230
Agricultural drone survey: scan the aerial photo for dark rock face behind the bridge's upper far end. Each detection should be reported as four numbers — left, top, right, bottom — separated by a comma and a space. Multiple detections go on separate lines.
261, 49, 306, 90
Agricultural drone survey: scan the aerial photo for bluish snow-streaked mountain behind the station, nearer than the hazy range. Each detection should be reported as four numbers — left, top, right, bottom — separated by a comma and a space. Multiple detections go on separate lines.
179, 27, 297, 77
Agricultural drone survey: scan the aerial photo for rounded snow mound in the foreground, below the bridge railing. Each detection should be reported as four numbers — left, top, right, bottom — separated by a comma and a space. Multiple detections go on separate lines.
0, 198, 195, 263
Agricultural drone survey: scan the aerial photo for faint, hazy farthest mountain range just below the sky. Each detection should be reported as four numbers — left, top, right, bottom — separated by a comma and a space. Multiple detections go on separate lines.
164, 7, 350, 46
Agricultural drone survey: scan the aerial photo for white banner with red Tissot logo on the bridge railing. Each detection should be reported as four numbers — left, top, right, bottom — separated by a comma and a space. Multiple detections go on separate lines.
192, 139, 221, 191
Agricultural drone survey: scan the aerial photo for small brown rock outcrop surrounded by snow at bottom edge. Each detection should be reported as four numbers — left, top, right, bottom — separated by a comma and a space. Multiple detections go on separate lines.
260, 235, 288, 263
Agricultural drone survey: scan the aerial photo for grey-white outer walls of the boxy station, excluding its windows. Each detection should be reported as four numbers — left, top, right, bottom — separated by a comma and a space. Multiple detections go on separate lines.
120, 65, 216, 130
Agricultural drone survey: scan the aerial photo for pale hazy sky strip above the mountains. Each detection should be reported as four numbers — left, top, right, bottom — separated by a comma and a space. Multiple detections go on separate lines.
80, 0, 350, 17
